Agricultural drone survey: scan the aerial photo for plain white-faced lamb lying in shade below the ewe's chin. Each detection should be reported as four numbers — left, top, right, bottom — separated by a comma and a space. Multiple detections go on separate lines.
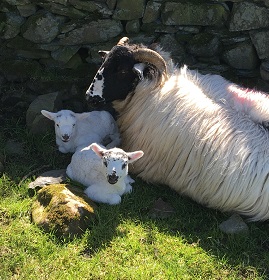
41, 110, 120, 153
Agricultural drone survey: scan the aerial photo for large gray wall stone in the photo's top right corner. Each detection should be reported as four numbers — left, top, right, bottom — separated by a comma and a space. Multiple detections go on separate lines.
229, 1, 269, 31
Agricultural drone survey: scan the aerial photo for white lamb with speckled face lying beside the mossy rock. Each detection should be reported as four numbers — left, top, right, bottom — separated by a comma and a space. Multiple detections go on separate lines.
66, 143, 144, 205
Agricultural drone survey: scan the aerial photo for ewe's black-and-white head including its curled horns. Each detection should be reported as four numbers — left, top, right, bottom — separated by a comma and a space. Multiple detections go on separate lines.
86, 37, 166, 106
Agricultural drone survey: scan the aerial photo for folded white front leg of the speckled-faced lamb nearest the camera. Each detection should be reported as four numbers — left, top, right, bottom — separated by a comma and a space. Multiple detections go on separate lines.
84, 184, 121, 205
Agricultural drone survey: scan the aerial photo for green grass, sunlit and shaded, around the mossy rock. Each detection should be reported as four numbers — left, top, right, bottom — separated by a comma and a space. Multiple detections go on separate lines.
0, 117, 269, 280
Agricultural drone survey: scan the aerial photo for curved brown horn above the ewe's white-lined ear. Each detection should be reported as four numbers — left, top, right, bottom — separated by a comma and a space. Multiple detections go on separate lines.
134, 49, 167, 73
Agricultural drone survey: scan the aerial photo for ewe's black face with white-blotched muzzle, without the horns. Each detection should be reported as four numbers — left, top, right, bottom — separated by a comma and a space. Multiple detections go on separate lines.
86, 46, 139, 106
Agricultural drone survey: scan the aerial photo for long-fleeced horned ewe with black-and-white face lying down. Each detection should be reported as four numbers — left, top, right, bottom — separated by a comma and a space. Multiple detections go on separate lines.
86, 37, 269, 220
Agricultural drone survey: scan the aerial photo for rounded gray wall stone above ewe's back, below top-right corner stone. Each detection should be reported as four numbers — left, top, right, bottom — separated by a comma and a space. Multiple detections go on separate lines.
223, 42, 259, 70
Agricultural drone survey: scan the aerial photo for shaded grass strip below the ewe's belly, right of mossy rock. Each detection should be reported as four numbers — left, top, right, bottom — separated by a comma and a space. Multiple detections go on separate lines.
83, 178, 269, 275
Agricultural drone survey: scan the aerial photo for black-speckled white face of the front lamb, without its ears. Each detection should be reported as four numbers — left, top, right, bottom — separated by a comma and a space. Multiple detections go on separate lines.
102, 152, 128, 185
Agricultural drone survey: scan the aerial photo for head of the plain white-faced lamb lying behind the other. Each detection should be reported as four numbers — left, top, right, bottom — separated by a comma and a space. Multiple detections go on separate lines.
41, 110, 89, 142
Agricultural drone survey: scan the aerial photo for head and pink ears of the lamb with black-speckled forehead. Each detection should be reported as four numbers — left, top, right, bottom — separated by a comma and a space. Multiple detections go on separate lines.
90, 143, 144, 185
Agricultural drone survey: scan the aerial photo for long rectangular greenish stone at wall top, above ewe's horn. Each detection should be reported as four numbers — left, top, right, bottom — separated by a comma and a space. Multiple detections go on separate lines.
161, 2, 229, 26
